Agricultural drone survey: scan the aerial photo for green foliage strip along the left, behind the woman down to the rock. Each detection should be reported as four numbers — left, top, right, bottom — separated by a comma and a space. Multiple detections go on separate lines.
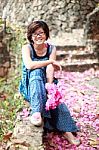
0, 27, 25, 141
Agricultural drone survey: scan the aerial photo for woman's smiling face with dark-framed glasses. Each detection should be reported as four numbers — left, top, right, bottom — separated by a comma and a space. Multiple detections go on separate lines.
32, 28, 46, 45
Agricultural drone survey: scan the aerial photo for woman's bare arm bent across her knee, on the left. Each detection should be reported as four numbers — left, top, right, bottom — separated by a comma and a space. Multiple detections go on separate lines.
22, 45, 54, 69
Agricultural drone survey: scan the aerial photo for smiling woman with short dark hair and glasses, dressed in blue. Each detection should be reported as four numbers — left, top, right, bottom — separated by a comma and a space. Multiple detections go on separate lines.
20, 21, 80, 145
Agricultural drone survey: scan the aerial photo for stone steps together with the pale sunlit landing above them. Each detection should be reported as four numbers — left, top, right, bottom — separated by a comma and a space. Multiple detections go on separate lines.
49, 29, 99, 72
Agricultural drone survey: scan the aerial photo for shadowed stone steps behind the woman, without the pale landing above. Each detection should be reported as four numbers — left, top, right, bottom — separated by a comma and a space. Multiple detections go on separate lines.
57, 46, 99, 72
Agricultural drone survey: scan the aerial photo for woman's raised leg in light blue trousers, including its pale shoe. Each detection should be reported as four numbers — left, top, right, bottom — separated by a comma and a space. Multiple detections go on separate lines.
29, 79, 43, 126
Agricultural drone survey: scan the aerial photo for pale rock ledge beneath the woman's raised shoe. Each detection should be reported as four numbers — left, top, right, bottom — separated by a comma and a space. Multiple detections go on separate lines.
8, 117, 44, 150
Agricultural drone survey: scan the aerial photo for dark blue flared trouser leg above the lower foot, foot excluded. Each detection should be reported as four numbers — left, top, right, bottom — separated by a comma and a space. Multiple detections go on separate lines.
45, 103, 79, 132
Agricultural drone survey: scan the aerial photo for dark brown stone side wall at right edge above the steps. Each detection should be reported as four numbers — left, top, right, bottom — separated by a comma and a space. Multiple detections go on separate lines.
85, 7, 99, 60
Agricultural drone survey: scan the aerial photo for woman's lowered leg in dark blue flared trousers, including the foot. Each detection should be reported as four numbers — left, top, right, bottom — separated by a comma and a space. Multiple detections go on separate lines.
45, 104, 80, 145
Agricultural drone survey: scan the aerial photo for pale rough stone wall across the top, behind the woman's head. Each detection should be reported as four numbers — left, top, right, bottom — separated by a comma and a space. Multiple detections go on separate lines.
0, 0, 99, 36
